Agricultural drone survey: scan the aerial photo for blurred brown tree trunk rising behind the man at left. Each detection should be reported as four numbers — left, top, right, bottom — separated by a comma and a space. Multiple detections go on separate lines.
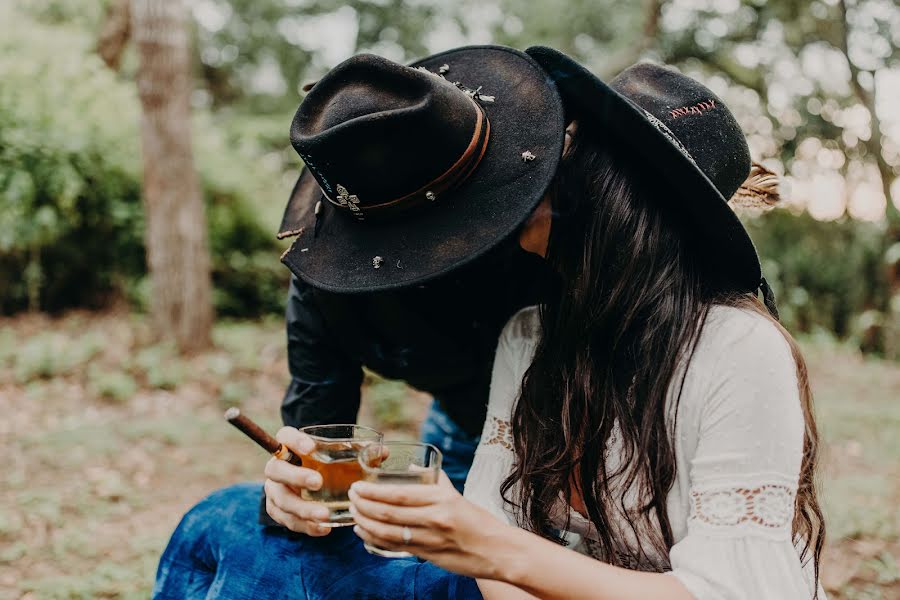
131, 0, 213, 352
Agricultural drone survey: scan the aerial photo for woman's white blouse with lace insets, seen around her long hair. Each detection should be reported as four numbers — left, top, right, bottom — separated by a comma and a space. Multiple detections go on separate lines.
465, 307, 825, 600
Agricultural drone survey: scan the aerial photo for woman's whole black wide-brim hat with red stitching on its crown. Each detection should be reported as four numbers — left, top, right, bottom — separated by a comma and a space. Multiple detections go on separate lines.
526, 46, 774, 294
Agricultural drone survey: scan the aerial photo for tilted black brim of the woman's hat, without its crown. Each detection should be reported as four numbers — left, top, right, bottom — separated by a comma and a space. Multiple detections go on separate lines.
525, 46, 762, 292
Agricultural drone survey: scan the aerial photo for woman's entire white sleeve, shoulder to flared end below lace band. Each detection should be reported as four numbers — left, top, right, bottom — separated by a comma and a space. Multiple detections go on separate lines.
670, 319, 824, 600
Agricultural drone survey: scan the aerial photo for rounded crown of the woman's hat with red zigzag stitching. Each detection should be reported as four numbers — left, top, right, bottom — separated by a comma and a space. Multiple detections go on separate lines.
610, 63, 751, 199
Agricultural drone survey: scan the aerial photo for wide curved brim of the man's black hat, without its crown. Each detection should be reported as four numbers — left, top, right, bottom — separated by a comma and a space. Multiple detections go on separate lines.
279, 46, 565, 293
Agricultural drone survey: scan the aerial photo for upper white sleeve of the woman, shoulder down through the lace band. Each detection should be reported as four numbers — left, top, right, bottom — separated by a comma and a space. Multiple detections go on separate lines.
688, 321, 804, 539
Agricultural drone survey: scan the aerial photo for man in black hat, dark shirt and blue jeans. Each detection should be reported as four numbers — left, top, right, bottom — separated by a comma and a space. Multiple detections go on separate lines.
155, 46, 564, 597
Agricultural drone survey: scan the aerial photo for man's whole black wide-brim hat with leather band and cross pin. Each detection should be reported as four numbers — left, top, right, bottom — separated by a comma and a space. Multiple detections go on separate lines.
279, 46, 565, 292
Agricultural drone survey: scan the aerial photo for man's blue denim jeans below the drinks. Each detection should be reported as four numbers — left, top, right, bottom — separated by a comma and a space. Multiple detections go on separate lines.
153, 404, 481, 600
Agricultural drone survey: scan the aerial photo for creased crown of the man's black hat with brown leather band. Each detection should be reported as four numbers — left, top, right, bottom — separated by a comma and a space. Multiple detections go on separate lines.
291, 54, 479, 214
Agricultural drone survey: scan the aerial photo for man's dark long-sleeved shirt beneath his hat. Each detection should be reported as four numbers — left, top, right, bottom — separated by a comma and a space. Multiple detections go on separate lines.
281, 240, 549, 435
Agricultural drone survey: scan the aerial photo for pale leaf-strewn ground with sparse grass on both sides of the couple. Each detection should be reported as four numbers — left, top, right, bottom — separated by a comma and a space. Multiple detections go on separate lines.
0, 313, 900, 600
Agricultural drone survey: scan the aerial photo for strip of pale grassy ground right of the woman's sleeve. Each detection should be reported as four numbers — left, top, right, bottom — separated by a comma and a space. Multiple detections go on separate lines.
806, 344, 900, 600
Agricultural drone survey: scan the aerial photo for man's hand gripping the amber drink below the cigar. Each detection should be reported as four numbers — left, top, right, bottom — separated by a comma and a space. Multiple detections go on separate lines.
265, 427, 331, 537
